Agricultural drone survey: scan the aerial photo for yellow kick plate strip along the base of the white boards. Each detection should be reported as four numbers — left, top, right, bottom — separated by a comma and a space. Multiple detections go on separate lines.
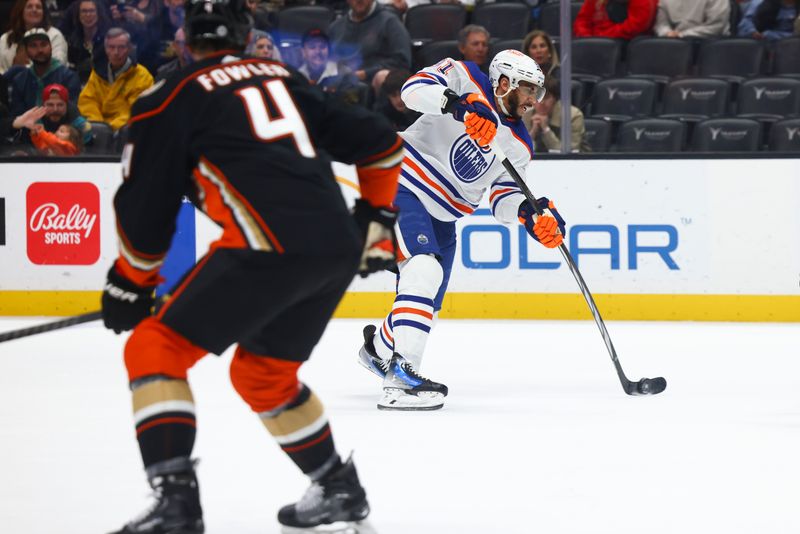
0, 291, 800, 322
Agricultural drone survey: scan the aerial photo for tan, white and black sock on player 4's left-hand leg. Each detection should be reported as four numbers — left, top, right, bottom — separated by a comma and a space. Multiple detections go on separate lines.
131, 375, 196, 468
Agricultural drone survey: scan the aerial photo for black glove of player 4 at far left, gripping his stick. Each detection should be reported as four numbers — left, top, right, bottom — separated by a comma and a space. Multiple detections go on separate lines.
102, 266, 155, 334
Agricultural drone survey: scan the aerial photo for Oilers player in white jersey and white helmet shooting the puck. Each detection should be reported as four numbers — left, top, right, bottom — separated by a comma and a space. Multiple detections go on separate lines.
359, 50, 564, 410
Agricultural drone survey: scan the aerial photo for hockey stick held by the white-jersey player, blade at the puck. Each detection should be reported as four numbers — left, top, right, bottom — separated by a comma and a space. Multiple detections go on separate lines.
490, 141, 667, 395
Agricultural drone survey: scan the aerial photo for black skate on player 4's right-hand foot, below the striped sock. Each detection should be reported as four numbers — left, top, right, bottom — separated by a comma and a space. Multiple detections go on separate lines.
278, 456, 369, 533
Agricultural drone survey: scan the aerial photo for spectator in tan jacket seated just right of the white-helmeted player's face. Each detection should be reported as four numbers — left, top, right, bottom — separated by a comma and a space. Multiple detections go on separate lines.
522, 77, 591, 152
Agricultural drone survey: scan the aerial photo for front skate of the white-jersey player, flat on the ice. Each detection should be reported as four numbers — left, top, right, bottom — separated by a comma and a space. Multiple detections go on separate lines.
378, 353, 447, 411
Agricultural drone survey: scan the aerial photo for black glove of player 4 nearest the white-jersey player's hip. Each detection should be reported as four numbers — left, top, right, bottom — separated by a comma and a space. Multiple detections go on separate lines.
353, 199, 397, 278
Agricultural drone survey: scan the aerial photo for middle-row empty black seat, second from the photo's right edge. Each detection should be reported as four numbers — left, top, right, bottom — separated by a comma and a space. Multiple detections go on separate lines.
662, 78, 730, 121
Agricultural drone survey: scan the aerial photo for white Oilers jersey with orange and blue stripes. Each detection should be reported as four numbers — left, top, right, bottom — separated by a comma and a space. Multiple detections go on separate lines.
400, 58, 533, 224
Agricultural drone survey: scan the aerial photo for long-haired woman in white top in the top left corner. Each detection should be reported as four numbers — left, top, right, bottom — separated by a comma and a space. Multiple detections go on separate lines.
0, 0, 67, 74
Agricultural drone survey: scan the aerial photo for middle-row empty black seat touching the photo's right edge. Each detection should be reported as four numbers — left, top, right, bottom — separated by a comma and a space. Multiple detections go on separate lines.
738, 78, 800, 122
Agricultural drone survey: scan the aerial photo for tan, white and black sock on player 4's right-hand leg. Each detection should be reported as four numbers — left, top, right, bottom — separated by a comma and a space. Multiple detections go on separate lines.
258, 384, 342, 480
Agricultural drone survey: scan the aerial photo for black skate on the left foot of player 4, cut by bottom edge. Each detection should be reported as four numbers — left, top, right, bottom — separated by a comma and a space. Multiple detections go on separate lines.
112, 458, 205, 534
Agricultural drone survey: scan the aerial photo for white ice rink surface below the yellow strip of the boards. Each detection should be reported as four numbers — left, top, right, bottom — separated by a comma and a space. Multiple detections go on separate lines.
0, 319, 800, 534
